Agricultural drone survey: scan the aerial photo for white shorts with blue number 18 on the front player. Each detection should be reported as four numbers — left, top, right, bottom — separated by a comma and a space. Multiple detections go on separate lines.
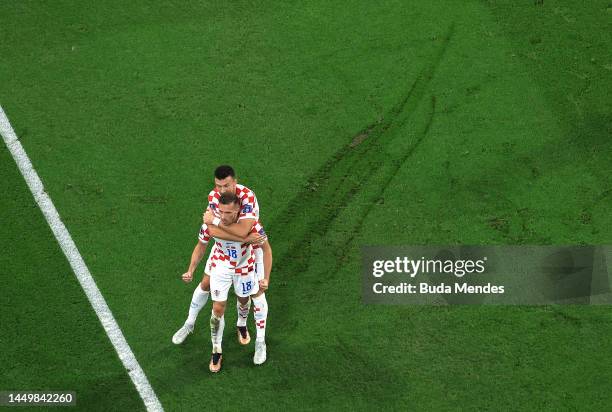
206, 264, 259, 302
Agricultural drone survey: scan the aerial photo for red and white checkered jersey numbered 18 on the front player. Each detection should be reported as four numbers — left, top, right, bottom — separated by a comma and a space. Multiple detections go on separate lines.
198, 222, 266, 275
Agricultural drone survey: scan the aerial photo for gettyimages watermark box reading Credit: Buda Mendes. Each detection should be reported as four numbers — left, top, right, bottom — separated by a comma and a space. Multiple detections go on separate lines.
361, 246, 612, 305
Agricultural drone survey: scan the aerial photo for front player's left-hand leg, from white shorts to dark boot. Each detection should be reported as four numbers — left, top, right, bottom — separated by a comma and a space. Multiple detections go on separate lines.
208, 271, 232, 372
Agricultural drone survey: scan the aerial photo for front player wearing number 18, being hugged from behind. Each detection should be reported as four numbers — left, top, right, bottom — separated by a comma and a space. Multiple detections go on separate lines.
179, 193, 272, 372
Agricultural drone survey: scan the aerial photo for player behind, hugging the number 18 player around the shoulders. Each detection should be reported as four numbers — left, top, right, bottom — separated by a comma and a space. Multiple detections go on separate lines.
172, 165, 268, 345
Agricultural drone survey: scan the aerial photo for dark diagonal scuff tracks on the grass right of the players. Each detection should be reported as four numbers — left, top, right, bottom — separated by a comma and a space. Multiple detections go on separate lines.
268, 24, 455, 273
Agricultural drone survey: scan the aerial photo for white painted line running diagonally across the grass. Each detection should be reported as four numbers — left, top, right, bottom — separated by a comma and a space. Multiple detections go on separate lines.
0, 106, 163, 411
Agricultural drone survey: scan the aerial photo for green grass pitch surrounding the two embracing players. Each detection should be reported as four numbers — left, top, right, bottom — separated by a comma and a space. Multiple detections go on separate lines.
0, 1, 612, 410
